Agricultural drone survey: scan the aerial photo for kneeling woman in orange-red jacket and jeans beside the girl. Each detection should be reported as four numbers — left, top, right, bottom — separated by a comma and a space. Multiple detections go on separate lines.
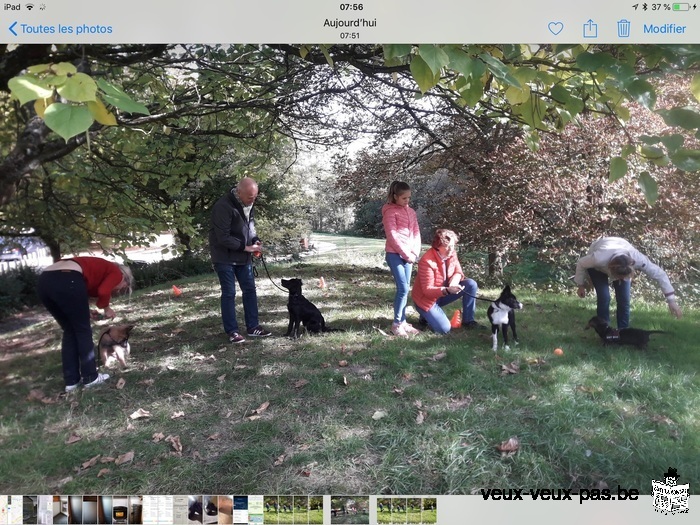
411, 229, 480, 334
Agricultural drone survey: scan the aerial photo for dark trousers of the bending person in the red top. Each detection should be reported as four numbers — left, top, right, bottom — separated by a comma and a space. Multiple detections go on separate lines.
37, 270, 97, 386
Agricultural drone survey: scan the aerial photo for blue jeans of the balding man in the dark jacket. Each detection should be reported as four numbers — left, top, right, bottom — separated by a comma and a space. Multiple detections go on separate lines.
214, 263, 260, 334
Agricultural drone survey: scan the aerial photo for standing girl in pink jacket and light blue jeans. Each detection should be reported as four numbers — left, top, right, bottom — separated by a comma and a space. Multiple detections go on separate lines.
382, 181, 420, 337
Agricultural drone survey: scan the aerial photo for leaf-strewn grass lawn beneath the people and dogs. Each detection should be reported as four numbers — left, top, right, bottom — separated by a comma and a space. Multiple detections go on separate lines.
0, 236, 700, 496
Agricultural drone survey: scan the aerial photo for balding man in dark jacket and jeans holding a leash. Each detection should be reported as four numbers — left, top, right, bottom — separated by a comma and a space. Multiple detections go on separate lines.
209, 177, 270, 343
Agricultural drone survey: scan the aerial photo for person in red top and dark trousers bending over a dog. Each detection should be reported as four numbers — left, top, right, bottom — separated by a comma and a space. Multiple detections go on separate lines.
37, 257, 134, 392
